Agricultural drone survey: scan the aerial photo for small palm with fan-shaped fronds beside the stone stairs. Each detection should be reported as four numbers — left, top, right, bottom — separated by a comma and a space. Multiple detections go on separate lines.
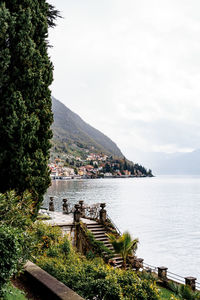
107, 232, 139, 269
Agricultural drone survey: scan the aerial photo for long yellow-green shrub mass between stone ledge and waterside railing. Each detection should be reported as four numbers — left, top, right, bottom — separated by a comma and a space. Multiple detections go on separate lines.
38, 252, 160, 300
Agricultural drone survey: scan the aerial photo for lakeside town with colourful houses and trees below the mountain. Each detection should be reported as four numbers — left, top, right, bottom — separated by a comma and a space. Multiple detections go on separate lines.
49, 153, 153, 180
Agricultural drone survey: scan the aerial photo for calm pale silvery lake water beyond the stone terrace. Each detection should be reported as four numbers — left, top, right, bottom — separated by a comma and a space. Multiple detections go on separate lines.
44, 176, 200, 281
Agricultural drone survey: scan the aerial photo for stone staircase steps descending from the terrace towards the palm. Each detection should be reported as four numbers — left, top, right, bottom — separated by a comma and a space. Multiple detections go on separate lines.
87, 222, 122, 268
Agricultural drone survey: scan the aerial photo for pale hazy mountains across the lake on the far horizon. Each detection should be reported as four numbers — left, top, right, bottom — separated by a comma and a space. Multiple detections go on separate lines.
135, 149, 200, 175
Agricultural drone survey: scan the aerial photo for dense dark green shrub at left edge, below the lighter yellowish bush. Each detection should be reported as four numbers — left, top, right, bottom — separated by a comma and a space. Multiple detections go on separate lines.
0, 225, 27, 292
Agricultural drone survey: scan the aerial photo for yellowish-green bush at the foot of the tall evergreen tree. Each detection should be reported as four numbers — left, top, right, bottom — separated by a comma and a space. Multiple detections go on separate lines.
0, 191, 33, 229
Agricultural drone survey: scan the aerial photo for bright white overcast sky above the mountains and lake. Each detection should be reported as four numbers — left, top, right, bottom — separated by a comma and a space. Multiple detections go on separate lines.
49, 0, 200, 164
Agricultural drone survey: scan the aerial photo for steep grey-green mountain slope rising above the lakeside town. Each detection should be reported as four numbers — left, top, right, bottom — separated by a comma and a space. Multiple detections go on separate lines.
52, 97, 123, 157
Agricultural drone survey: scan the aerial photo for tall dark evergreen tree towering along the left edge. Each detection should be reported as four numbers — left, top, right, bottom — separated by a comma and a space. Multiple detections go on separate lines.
0, 0, 58, 212
